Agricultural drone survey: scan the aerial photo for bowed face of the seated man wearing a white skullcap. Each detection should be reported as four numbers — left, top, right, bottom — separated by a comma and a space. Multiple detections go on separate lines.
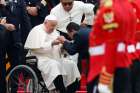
44, 20, 57, 33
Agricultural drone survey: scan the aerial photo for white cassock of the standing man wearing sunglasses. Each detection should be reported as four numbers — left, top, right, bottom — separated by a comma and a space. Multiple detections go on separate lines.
50, 1, 94, 33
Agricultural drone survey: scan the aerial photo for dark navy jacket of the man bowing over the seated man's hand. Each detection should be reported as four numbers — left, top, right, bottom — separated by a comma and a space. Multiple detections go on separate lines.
63, 28, 90, 59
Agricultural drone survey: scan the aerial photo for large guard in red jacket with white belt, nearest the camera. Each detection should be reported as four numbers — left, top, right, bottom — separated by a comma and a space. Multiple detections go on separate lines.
88, 0, 136, 93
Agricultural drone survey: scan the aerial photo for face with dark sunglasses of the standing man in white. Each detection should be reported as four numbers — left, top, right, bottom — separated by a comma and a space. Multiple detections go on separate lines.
60, 0, 74, 12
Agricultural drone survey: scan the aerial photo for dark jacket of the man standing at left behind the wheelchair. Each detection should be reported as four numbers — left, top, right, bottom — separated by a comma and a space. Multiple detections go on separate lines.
6, 0, 31, 44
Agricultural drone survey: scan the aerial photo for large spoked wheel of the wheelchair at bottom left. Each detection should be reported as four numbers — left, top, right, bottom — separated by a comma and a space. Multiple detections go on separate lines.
6, 65, 38, 93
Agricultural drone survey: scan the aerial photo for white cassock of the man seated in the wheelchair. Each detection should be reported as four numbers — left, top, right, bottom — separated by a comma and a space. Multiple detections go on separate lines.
25, 24, 80, 90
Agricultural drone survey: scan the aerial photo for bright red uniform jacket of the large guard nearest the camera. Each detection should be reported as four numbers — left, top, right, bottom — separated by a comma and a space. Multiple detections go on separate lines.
88, 0, 136, 82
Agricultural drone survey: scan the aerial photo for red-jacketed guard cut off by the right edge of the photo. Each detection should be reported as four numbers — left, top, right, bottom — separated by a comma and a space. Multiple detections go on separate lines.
129, 0, 140, 93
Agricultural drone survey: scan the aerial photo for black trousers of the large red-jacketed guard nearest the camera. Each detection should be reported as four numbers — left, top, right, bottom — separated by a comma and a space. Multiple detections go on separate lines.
113, 68, 133, 93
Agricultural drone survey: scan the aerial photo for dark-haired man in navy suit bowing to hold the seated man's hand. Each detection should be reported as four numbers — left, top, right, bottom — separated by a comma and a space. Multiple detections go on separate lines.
59, 22, 90, 71
